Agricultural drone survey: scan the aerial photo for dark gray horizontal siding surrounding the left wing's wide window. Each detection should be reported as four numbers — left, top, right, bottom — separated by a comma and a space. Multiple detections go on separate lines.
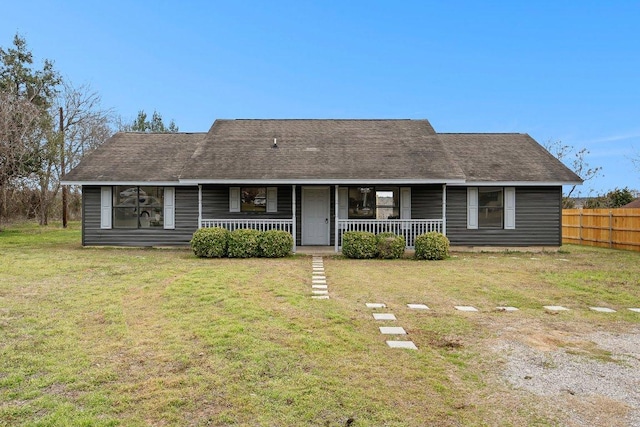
82, 186, 198, 246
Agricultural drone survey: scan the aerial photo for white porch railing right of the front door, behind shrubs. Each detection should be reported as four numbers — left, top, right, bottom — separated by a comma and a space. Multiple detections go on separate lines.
338, 219, 443, 249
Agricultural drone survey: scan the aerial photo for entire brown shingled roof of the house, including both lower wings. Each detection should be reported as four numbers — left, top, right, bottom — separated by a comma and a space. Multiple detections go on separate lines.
65, 120, 581, 185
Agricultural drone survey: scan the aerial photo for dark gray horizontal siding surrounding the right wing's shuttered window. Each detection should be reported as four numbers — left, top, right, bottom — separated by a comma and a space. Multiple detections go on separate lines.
447, 186, 562, 246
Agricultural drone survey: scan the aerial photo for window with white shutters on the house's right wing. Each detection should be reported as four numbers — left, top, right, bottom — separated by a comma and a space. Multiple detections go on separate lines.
467, 187, 516, 230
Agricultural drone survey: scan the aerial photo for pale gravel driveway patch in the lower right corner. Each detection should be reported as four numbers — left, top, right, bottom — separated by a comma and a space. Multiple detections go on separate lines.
494, 328, 640, 426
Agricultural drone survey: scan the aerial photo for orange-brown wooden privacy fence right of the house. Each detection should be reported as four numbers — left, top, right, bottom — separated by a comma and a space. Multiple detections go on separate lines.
562, 209, 640, 251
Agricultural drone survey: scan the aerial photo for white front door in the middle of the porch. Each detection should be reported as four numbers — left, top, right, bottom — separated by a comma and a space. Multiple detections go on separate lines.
302, 187, 330, 246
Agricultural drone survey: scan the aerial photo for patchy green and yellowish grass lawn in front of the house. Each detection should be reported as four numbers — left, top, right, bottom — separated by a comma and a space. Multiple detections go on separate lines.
0, 224, 640, 426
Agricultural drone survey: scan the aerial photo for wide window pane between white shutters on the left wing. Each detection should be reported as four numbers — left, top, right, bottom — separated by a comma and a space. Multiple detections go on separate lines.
113, 186, 165, 228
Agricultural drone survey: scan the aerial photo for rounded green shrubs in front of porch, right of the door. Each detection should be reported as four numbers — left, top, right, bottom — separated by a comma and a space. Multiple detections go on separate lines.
342, 231, 449, 260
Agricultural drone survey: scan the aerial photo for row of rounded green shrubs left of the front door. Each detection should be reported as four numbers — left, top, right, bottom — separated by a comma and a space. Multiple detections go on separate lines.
191, 227, 293, 258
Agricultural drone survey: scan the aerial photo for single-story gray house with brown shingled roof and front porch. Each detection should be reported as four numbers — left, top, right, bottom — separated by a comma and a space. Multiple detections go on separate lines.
64, 120, 582, 251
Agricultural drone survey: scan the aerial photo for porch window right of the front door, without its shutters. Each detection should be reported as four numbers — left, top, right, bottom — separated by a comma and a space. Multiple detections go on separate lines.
348, 187, 400, 219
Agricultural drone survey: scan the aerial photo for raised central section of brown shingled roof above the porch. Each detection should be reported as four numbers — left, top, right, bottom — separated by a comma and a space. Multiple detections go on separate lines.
182, 120, 464, 182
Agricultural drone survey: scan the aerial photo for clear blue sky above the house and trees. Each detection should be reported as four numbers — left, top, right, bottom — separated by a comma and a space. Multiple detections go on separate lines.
0, 0, 640, 195
